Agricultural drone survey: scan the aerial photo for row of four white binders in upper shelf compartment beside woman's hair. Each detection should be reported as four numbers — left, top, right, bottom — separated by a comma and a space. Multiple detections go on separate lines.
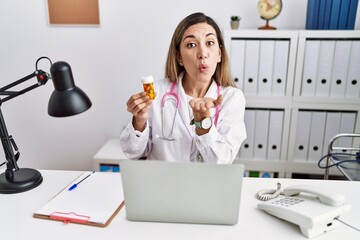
230, 39, 290, 96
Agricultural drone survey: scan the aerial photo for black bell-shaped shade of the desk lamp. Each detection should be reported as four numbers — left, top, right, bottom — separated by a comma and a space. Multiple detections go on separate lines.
48, 62, 91, 117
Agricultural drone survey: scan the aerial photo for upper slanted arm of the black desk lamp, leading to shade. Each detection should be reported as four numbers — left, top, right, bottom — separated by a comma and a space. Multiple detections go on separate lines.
0, 70, 50, 105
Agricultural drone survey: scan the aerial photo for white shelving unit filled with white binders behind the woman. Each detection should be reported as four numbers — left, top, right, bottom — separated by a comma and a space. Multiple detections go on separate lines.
224, 30, 360, 177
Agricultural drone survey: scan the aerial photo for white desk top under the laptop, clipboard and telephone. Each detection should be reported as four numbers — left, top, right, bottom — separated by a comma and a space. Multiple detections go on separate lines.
0, 169, 360, 240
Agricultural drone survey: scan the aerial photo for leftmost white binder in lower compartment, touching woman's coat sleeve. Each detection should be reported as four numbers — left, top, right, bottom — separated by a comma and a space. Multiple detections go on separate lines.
239, 109, 256, 160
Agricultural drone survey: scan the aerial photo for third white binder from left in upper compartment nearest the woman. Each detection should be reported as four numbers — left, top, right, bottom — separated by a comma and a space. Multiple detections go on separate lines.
258, 40, 275, 96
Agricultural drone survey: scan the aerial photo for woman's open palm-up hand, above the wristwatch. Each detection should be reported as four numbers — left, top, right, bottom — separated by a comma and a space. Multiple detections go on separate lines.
189, 95, 223, 121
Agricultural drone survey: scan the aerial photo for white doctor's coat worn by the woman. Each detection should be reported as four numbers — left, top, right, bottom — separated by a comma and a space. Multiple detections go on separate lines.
120, 75, 246, 164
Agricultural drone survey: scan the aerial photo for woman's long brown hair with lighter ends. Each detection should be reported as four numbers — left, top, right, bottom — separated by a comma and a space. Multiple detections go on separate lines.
165, 12, 236, 87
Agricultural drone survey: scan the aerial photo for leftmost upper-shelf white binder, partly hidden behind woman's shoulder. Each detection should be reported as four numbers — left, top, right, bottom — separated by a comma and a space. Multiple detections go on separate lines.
230, 39, 245, 90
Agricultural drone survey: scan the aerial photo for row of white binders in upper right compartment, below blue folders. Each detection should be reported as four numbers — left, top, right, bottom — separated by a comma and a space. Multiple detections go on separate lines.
301, 39, 360, 98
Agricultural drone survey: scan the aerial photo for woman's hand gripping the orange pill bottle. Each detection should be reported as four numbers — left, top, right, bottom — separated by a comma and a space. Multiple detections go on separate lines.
126, 92, 156, 131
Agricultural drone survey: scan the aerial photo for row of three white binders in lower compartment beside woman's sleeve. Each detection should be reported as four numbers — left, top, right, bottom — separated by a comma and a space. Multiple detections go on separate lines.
239, 109, 284, 161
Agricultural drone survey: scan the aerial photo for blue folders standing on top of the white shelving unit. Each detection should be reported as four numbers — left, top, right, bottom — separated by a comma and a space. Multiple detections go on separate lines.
306, 0, 358, 30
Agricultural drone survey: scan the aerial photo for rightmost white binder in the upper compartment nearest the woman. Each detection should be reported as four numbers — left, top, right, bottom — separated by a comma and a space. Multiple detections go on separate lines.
271, 40, 289, 96
